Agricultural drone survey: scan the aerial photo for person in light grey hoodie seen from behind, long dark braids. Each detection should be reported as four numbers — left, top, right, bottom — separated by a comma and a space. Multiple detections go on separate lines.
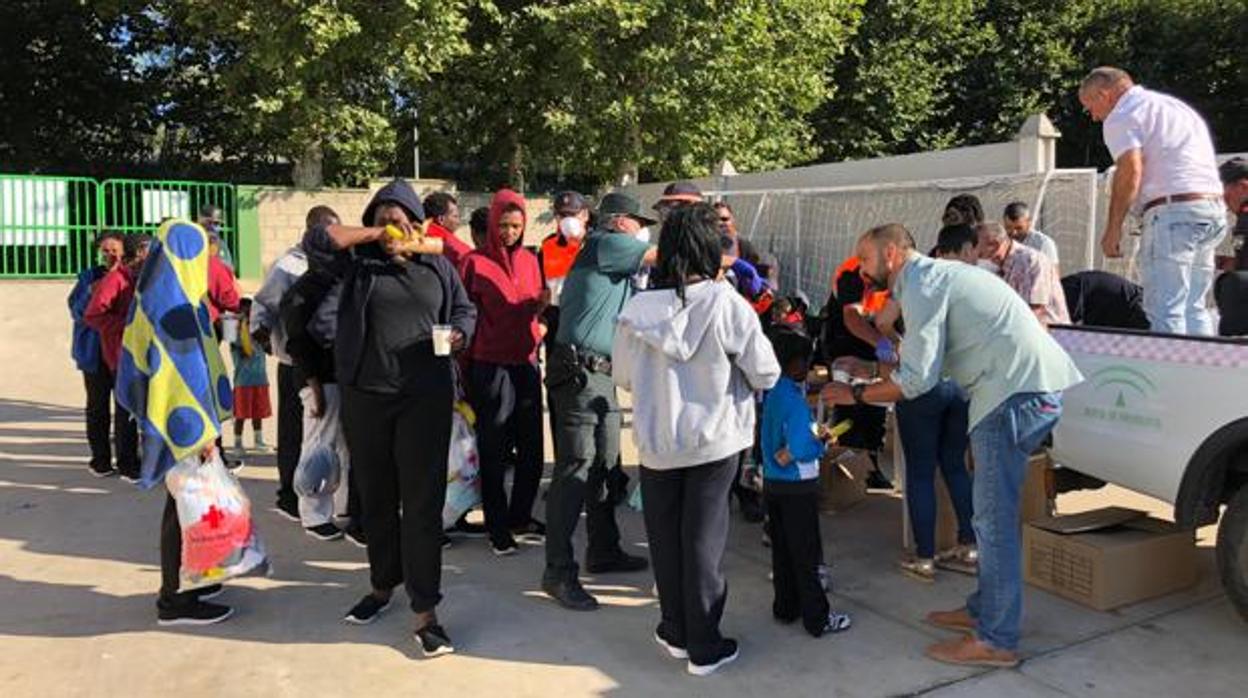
612, 204, 780, 676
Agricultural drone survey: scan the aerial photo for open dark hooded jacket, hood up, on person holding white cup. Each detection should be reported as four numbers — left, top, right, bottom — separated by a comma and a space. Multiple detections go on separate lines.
303, 180, 477, 386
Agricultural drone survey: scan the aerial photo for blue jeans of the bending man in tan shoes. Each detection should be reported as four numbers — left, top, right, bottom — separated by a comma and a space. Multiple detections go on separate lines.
966, 392, 1062, 651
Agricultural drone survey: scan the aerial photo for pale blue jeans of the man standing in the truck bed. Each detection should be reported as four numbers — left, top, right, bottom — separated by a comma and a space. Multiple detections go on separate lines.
1138, 200, 1227, 336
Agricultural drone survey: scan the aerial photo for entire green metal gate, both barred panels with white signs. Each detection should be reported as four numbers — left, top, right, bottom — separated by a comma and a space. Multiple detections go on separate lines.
0, 175, 238, 278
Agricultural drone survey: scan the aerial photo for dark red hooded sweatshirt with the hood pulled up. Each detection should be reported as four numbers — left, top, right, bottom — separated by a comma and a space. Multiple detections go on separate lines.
462, 189, 543, 365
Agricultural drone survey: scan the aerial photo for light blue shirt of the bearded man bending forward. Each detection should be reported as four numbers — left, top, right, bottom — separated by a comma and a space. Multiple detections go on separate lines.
892, 253, 1083, 430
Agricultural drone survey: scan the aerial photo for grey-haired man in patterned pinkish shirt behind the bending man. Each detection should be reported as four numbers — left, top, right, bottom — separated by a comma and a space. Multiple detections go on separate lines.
975, 221, 1071, 326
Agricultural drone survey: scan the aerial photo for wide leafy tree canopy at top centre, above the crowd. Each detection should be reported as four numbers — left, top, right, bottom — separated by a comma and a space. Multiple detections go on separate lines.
428, 0, 859, 188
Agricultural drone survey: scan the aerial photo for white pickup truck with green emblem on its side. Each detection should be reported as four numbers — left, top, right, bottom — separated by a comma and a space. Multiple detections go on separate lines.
1053, 327, 1248, 619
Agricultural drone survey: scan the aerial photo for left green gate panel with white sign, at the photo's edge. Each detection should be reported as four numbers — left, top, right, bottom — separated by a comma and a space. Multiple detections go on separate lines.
0, 175, 99, 278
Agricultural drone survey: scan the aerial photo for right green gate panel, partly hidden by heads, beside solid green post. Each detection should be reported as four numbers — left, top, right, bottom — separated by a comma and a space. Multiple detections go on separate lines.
100, 180, 238, 263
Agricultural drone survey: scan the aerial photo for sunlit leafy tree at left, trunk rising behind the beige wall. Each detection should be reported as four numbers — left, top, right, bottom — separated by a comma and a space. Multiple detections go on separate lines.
151, 0, 466, 186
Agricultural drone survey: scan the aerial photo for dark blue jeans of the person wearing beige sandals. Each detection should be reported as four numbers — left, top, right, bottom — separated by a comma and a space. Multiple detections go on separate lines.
897, 381, 975, 559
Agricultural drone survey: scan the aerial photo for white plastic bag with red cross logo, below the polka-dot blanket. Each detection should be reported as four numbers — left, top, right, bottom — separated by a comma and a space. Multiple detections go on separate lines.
165, 452, 268, 592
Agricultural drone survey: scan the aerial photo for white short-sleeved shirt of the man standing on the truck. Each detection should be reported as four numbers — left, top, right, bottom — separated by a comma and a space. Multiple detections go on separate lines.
1104, 85, 1222, 206
